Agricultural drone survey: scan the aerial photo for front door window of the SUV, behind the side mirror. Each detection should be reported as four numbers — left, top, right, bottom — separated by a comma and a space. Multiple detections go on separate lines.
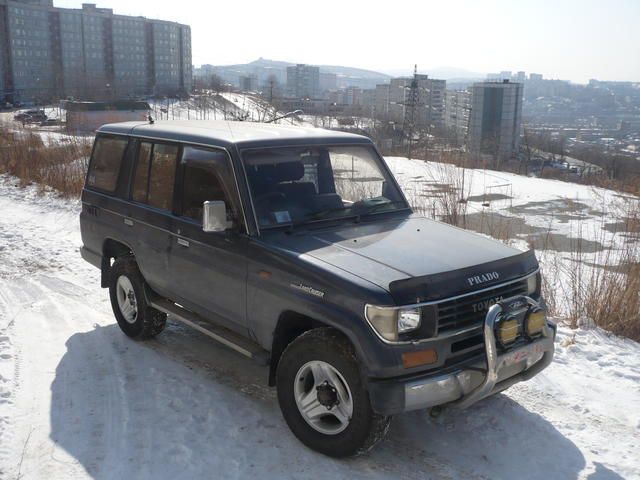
181, 147, 239, 222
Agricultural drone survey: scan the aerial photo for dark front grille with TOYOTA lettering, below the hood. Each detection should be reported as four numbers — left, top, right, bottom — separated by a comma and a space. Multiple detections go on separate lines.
436, 280, 527, 333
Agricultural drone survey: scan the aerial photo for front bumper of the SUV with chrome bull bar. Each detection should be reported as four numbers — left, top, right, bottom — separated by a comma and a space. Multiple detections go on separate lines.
369, 299, 555, 415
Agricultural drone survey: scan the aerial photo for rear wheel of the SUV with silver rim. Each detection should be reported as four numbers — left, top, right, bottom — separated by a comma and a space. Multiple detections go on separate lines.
109, 257, 167, 340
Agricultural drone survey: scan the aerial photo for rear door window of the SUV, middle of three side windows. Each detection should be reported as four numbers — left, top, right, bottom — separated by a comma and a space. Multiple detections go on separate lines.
133, 142, 178, 210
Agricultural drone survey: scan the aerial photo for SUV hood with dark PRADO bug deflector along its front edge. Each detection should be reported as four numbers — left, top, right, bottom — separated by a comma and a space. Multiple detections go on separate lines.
272, 216, 537, 303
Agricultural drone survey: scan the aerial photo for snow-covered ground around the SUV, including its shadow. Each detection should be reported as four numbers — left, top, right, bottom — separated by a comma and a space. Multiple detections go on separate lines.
0, 163, 640, 480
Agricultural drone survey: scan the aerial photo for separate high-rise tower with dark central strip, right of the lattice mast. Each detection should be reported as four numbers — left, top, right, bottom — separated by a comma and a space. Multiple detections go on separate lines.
468, 80, 523, 161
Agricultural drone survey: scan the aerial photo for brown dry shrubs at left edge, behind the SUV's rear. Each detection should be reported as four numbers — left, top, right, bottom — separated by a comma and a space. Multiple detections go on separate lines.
0, 130, 92, 197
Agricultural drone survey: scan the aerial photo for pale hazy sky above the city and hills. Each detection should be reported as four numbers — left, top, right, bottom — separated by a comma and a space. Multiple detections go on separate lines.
54, 0, 640, 83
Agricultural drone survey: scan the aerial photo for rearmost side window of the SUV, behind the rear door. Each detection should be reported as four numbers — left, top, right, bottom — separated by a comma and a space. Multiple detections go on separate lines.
87, 137, 128, 192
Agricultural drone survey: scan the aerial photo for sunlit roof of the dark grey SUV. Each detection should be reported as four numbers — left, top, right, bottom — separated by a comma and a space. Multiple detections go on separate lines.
97, 120, 371, 148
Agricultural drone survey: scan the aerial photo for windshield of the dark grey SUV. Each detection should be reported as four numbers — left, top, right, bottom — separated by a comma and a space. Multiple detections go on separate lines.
243, 146, 408, 227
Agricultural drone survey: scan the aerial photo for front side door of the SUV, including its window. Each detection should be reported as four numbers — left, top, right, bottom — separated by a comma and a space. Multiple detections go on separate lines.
169, 145, 248, 333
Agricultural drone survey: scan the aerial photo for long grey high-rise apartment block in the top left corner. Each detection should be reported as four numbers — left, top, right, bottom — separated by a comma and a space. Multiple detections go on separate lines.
0, 0, 192, 101
